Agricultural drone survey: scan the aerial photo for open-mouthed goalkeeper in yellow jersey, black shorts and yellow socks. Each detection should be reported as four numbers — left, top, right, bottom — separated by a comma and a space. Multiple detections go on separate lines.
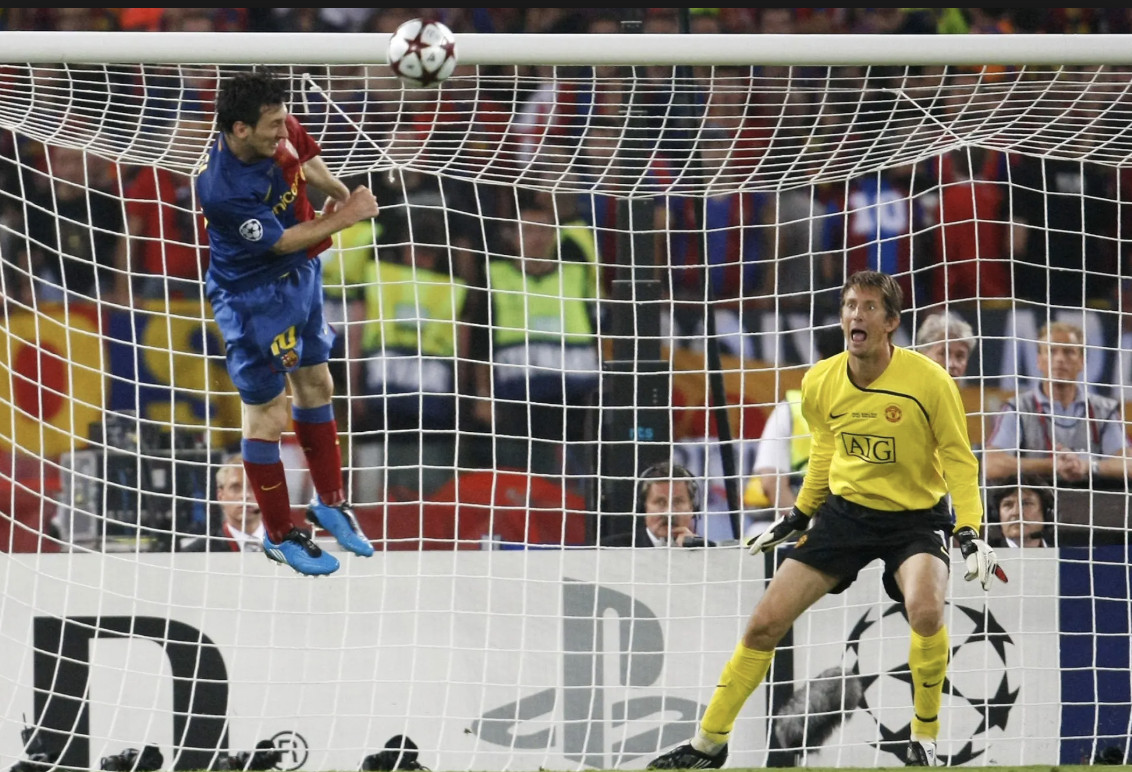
649, 271, 1006, 769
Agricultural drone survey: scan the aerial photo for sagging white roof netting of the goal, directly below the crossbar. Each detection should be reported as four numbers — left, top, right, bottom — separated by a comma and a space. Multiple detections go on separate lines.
0, 59, 1129, 187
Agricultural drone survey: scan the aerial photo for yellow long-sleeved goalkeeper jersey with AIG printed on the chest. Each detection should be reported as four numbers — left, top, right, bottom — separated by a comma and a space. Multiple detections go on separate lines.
797, 346, 983, 530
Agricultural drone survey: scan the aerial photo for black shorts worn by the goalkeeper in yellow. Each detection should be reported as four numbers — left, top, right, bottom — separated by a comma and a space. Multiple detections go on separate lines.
786, 496, 952, 603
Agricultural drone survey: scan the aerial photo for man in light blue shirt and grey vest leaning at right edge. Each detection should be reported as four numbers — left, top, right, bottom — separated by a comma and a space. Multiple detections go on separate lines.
984, 321, 1130, 489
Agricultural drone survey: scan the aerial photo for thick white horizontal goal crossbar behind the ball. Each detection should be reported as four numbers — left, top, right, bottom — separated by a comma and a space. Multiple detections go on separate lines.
0, 32, 1132, 66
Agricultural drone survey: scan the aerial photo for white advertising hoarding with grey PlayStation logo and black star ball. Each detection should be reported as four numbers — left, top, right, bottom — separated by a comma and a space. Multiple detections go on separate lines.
0, 549, 1058, 770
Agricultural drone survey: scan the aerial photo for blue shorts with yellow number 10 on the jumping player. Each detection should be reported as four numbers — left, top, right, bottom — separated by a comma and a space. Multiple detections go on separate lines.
208, 258, 334, 405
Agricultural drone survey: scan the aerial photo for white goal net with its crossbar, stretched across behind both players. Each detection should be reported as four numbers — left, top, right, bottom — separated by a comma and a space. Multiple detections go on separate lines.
0, 33, 1132, 770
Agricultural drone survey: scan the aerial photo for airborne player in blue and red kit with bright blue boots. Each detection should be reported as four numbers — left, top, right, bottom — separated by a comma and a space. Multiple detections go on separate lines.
196, 72, 377, 575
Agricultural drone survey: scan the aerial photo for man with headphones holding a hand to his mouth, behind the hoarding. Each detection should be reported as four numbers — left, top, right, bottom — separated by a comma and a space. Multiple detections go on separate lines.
601, 461, 714, 547
